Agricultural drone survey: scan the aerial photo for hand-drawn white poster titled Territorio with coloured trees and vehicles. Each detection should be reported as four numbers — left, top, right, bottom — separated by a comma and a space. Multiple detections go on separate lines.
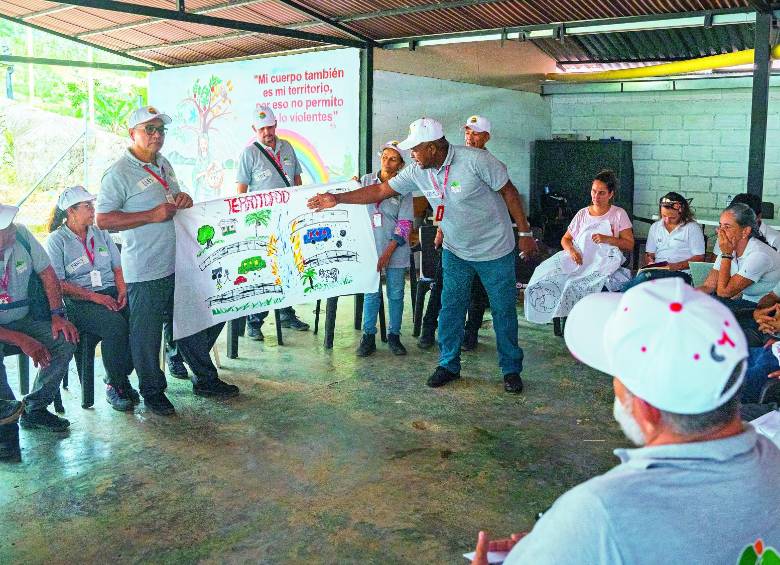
173, 181, 379, 339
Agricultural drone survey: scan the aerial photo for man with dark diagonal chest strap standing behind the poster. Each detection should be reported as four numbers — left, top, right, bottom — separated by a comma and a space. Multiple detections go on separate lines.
236, 105, 309, 341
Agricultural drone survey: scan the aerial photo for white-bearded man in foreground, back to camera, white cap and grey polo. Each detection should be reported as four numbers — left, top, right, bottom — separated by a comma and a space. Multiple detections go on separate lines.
474, 278, 780, 565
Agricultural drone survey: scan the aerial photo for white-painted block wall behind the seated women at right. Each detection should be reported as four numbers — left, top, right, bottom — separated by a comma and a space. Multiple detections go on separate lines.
550, 88, 780, 223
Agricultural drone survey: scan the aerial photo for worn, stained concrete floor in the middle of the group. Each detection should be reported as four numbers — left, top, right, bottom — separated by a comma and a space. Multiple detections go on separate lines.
0, 298, 626, 564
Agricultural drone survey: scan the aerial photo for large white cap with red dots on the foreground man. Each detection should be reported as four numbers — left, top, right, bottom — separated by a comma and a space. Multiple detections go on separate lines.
564, 277, 748, 414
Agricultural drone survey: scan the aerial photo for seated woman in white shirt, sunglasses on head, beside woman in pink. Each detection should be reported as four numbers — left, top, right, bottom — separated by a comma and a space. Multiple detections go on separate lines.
645, 192, 705, 271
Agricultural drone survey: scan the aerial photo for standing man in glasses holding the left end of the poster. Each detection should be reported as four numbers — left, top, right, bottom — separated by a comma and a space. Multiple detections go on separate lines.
96, 106, 238, 415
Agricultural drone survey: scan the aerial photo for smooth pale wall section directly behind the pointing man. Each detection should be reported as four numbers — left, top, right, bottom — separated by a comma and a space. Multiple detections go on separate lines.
373, 71, 551, 204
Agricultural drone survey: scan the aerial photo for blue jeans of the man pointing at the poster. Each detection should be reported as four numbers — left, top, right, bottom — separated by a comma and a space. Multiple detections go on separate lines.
439, 249, 523, 375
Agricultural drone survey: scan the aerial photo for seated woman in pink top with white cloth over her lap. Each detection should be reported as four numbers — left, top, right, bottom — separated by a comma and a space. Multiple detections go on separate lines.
525, 170, 634, 324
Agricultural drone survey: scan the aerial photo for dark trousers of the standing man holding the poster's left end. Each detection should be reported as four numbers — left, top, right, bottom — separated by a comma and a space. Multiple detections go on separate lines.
127, 275, 225, 397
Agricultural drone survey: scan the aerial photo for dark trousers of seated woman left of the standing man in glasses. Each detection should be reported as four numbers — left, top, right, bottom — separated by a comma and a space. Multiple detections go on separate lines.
65, 286, 133, 387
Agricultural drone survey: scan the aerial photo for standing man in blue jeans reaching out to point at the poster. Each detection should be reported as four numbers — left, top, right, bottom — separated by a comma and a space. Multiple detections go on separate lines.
308, 118, 536, 393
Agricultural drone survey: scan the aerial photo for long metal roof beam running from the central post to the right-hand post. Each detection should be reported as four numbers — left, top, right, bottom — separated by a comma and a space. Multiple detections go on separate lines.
378, 8, 768, 49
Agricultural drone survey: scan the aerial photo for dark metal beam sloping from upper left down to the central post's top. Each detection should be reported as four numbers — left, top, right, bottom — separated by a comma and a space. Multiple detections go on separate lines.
52, 0, 365, 47
